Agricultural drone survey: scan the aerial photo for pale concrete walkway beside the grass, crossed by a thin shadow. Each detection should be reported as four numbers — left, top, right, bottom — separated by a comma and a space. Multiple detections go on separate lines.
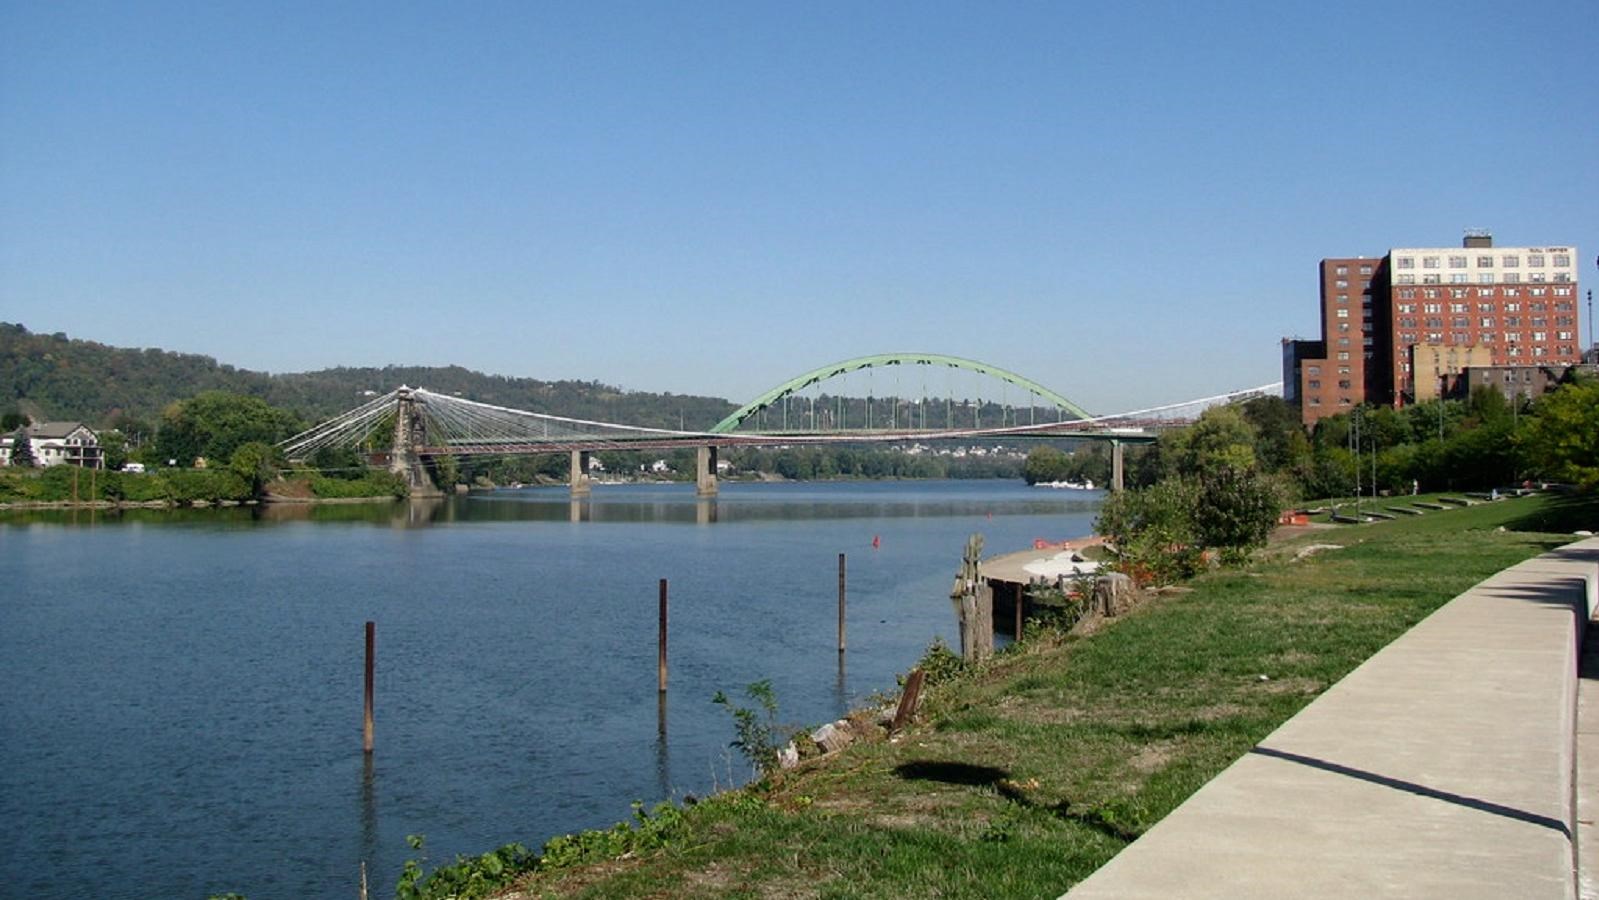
1067, 539, 1599, 900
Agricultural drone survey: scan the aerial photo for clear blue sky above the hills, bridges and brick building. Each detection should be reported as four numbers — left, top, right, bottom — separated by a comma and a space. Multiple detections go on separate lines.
0, 0, 1599, 411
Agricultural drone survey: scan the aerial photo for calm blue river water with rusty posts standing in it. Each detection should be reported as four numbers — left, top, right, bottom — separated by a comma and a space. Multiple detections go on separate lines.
0, 481, 1100, 900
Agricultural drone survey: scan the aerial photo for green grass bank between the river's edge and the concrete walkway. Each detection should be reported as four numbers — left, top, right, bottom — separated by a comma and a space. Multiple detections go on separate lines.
492, 497, 1599, 897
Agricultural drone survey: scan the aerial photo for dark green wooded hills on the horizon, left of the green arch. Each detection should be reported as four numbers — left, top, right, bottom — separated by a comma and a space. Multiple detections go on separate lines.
0, 323, 737, 430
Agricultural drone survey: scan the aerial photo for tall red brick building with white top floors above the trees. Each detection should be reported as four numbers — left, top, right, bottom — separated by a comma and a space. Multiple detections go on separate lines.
1282, 232, 1581, 425
